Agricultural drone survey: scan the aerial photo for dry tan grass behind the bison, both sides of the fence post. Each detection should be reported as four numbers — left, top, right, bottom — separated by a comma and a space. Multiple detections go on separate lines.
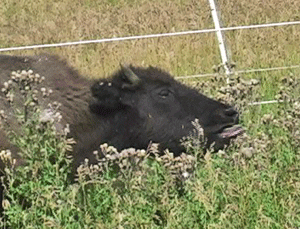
0, 0, 300, 77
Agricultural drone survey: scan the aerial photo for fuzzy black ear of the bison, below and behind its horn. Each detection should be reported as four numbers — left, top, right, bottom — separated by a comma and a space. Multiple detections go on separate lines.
89, 81, 123, 115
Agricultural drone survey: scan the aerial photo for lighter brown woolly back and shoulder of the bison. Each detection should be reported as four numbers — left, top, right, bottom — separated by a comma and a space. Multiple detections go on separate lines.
0, 55, 94, 169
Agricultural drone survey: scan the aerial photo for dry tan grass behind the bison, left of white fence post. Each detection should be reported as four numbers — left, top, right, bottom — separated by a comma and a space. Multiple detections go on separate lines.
0, 1, 217, 77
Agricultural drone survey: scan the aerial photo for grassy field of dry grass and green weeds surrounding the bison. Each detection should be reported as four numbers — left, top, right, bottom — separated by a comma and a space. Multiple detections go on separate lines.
0, 0, 300, 229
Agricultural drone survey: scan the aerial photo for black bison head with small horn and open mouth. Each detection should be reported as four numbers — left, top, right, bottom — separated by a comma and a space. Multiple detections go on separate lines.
89, 66, 242, 155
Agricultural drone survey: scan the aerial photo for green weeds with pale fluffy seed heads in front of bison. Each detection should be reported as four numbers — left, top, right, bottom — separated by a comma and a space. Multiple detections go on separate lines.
2, 69, 300, 228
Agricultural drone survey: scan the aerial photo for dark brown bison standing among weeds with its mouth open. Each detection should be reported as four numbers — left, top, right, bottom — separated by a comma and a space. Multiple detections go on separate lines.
0, 55, 242, 167
